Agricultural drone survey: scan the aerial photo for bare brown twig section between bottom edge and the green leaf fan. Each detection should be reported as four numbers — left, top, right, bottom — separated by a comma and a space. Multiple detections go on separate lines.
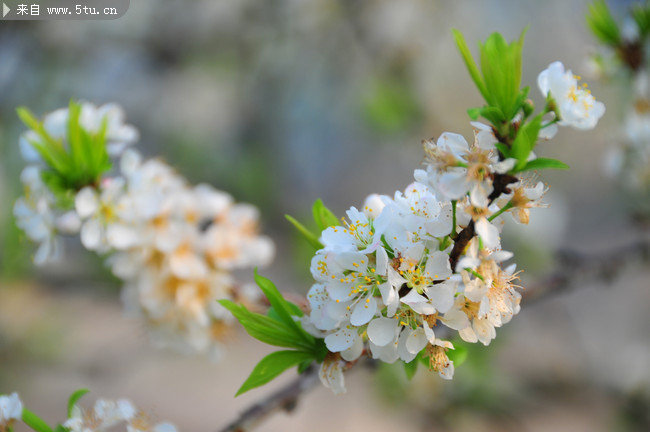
219, 365, 319, 432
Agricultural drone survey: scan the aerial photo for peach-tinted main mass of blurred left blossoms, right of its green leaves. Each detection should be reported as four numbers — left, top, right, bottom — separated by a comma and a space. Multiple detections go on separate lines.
103, 150, 274, 357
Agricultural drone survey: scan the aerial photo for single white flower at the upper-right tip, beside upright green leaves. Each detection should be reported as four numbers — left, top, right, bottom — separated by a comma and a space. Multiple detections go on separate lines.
537, 62, 605, 129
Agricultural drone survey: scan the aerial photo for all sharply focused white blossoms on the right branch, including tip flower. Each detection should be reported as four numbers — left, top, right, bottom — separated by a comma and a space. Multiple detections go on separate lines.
303, 63, 604, 393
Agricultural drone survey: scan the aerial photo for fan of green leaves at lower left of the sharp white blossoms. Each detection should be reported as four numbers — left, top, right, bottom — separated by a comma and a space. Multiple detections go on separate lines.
219, 271, 327, 396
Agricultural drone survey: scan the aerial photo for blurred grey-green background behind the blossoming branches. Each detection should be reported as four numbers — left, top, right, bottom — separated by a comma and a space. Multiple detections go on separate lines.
0, 0, 650, 431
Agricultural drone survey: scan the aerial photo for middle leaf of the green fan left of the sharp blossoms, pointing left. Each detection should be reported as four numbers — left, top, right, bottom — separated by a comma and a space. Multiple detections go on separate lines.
218, 299, 314, 351
